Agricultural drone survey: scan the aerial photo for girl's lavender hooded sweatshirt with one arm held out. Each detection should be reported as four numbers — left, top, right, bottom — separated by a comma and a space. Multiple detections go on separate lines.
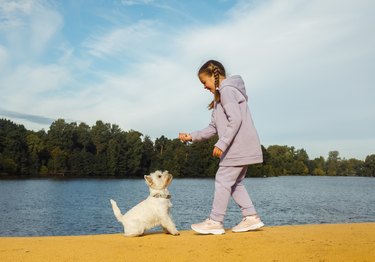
190, 76, 263, 166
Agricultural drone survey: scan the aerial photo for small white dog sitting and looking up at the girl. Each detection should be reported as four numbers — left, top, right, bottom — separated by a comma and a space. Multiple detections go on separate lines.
111, 171, 180, 236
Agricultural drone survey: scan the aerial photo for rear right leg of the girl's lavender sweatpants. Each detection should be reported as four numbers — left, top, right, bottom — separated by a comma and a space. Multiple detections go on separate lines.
232, 166, 256, 217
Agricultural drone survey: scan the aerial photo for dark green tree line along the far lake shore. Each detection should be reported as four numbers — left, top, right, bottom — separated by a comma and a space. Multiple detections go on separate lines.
0, 119, 375, 177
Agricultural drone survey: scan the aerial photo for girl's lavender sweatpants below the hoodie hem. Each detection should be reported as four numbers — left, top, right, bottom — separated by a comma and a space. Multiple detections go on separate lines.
210, 166, 256, 222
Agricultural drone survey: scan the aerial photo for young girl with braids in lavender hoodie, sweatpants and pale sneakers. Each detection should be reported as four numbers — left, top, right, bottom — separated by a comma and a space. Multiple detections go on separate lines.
179, 60, 264, 234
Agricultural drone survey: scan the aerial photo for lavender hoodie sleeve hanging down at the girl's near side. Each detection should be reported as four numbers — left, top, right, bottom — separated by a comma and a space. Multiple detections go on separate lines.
215, 86, 245, 152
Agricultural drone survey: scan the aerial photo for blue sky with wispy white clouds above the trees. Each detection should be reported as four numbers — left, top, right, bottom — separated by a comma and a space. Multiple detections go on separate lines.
0, 0, 375, 160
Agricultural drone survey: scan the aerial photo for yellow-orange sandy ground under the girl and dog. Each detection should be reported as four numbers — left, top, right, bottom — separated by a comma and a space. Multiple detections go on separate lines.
0, 223, 375, 262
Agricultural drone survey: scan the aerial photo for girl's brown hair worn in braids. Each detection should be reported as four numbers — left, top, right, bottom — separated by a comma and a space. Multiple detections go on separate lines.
198, 60, 226, 110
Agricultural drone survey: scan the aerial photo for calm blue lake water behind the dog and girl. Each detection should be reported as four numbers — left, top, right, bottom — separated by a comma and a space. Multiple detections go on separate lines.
0, 176, 375, 236
